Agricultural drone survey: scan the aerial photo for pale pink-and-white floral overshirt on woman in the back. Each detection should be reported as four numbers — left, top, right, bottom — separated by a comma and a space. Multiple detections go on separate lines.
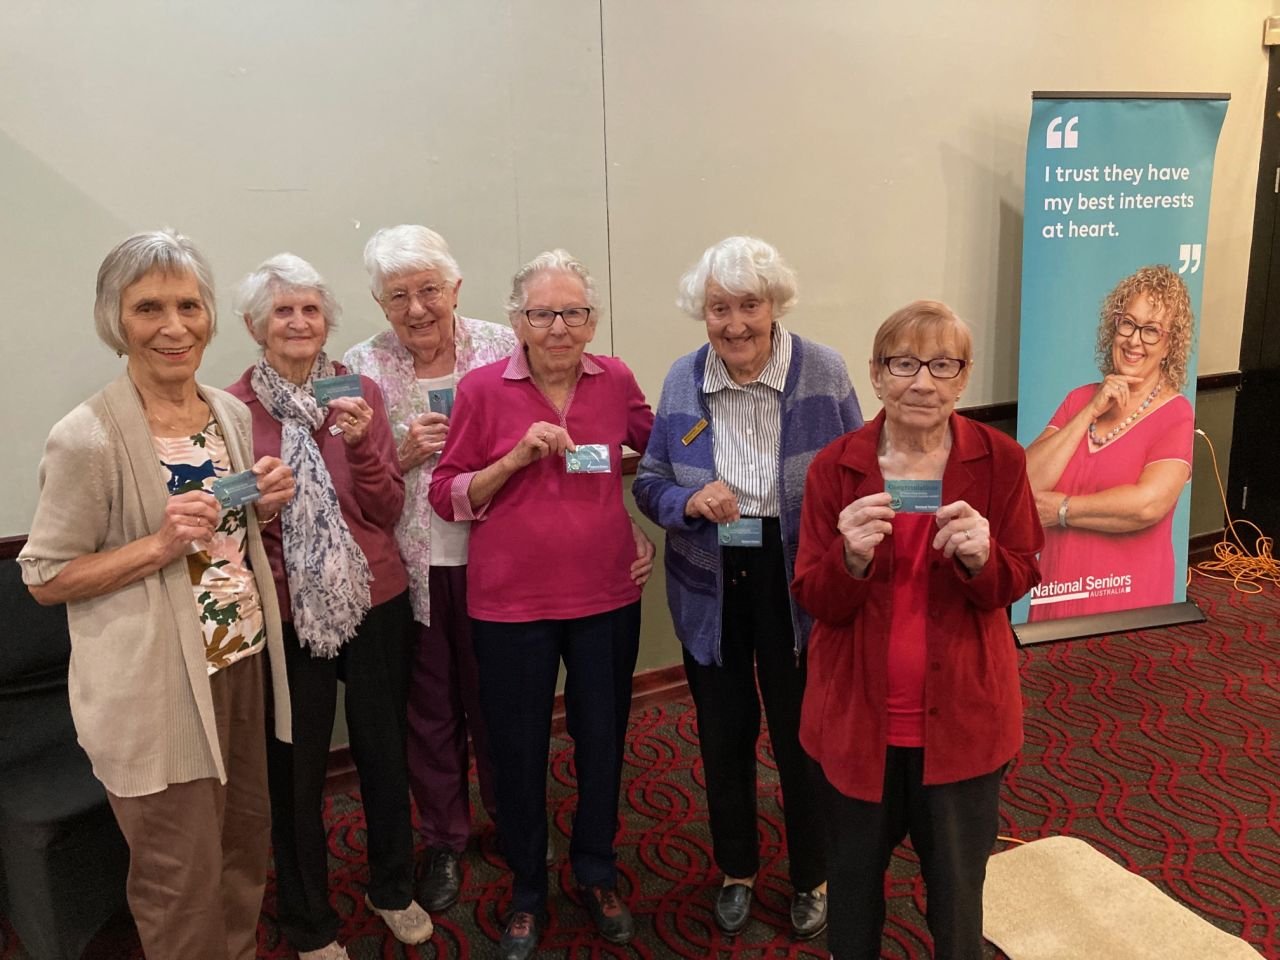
342, 315, 516, 625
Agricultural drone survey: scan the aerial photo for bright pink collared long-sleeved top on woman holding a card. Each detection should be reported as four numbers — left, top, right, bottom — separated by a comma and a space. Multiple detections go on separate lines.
430, 347, 653, 623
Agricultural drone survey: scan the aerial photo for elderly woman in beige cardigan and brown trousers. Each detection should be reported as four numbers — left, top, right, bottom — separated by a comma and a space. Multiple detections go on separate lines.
19, 232, 293, 960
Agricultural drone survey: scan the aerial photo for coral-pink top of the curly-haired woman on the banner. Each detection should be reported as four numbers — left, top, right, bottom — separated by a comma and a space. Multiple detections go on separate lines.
1028, 384, 1196, 622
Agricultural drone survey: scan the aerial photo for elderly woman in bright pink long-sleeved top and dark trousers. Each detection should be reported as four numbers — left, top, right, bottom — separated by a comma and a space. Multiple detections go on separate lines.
430, 250, 653, 960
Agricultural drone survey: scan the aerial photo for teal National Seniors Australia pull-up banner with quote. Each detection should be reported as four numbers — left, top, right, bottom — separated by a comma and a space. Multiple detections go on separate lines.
1014, 93, 1229, 644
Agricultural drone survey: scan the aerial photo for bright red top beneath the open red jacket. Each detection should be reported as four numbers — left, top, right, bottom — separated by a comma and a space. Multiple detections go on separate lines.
882, 513, 938, 746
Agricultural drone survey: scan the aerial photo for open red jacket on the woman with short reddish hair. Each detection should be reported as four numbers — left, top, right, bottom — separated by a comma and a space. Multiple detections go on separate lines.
791, 412, 1044, 803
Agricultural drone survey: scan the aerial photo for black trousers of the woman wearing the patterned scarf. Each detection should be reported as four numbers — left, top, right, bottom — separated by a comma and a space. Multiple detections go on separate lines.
266, 591, 413, 951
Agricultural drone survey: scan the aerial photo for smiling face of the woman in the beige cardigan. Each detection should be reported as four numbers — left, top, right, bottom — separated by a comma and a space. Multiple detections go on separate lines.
120, 270, 210, 390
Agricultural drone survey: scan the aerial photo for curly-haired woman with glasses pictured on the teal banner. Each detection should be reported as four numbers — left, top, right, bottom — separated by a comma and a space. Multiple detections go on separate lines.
1027, 266, 1196, 622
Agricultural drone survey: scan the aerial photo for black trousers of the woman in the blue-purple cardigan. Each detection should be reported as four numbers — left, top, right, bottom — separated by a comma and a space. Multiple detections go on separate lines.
685, 518, 827, 891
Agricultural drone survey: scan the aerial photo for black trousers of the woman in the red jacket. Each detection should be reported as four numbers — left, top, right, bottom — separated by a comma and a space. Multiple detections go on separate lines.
822, 746, 1005, 960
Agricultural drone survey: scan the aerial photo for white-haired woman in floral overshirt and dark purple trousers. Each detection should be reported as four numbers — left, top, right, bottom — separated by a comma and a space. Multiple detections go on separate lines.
344, 224, 516, 913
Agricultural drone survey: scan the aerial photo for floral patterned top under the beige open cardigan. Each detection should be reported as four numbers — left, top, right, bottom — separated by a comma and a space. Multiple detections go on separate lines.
151, 420, 266, 675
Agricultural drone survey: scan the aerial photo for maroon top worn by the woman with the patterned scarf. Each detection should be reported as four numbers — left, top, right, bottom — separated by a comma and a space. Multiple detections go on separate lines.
227, 364, 408, 621
